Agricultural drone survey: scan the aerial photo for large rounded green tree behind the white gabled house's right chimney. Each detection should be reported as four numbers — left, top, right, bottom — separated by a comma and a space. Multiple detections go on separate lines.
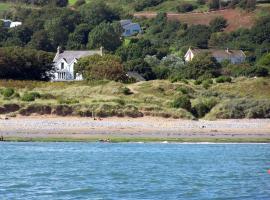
87, 23, 122, 51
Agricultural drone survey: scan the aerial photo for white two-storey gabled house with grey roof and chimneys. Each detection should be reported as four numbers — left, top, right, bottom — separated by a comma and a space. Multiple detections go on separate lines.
52, 47, 103, 81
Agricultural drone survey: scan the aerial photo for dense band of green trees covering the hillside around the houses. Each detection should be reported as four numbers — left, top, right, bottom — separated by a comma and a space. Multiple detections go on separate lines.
0, 2, 270, 80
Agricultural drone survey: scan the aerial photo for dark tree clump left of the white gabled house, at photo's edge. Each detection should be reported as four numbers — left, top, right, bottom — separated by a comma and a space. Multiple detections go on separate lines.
0, 47, 53, 80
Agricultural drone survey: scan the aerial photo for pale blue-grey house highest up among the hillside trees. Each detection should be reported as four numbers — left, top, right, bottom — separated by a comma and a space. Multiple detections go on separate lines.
120, 19, 142, 37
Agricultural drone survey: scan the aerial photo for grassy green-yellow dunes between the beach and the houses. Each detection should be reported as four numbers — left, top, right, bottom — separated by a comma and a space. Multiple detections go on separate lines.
0, 78, 270, 119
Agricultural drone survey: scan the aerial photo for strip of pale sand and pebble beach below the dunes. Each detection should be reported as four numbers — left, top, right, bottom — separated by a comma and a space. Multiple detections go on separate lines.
0, 116, 270, 139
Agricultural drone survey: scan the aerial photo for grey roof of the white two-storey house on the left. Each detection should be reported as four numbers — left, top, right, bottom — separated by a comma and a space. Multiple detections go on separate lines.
53, 50, 101, 64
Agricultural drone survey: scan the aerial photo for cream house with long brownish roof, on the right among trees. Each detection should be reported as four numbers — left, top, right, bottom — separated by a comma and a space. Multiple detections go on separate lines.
185, 48, 246, 64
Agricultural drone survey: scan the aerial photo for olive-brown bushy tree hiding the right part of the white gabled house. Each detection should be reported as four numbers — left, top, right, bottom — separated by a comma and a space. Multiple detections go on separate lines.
75, 54, 126, 81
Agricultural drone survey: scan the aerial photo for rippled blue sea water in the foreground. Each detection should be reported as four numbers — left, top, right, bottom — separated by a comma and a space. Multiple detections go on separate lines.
0, 143, 270, 200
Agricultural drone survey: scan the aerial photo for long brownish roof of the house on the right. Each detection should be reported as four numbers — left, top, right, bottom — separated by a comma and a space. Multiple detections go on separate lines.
191, 49, 246, 58
